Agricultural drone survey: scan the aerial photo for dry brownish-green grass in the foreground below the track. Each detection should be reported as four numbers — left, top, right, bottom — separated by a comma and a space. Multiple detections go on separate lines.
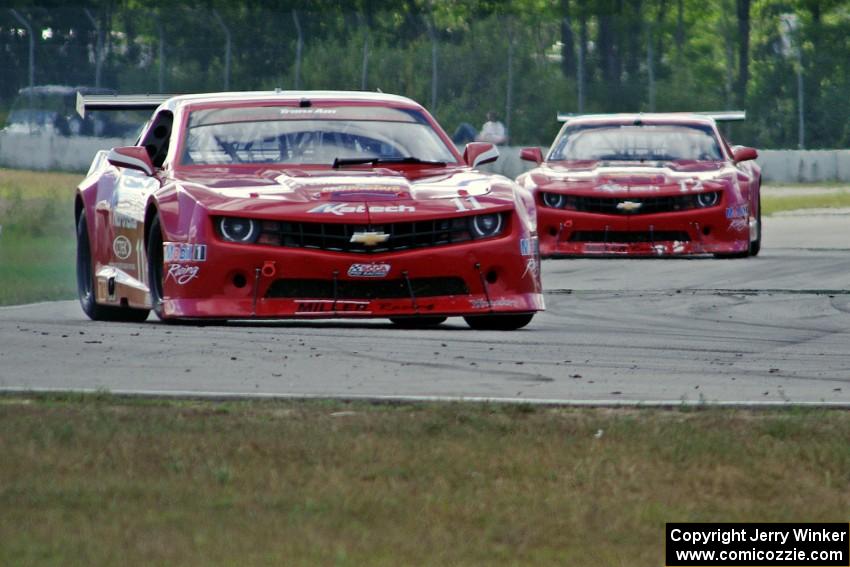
0, 394, 850, 566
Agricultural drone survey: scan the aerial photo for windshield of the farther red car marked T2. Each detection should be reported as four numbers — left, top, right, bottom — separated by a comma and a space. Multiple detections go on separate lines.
549, 124, 723, 161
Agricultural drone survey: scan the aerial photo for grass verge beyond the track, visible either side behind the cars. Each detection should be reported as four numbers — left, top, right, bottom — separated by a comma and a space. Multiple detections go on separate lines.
0, 169, 850, 305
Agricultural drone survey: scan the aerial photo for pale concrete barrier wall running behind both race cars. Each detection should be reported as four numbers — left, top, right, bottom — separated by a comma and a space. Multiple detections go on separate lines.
0, 132, 850, 183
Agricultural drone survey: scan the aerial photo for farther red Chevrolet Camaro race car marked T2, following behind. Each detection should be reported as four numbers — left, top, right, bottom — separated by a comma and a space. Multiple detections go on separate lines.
517, 112, 761, 257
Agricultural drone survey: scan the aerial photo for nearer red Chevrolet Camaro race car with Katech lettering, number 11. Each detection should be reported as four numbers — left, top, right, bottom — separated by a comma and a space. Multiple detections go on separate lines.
75, 91, 543, 330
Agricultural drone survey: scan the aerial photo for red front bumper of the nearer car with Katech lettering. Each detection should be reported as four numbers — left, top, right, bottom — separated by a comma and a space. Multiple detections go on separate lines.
162, 233, 544, 319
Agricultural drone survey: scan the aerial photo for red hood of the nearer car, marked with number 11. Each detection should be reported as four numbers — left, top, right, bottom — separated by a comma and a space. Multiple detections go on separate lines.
164, 168, 514, 217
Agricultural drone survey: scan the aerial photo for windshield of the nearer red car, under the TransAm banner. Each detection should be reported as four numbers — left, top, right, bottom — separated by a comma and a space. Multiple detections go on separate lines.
181, 106, 456, 165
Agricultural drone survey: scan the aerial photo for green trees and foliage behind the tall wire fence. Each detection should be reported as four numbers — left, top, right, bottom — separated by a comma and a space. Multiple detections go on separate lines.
0, 0, 850, 148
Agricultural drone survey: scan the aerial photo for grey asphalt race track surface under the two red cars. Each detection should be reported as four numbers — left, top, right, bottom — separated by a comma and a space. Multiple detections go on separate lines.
0, 211, 850, 406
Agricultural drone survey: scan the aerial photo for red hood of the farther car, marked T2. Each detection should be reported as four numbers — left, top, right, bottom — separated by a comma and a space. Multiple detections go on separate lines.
524, 161, 736, 196
